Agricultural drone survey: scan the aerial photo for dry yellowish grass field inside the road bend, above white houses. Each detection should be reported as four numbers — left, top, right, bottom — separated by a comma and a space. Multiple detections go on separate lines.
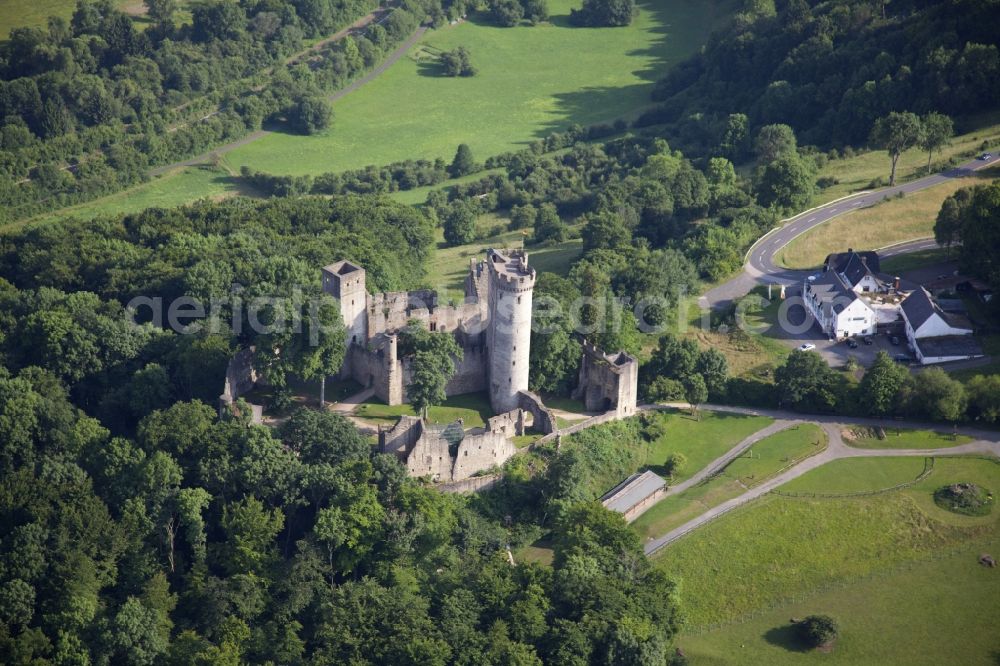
778, 167, 1000, 268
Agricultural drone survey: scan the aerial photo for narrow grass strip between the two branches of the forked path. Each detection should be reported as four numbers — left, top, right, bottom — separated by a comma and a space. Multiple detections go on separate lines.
632, 424, 826, 540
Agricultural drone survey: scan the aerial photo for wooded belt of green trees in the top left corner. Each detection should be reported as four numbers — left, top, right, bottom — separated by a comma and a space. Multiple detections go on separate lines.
0, 0, 461, 220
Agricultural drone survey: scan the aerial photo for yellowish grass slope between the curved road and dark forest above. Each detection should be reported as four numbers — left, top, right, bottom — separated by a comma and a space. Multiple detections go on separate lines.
812, 113, 1000, 206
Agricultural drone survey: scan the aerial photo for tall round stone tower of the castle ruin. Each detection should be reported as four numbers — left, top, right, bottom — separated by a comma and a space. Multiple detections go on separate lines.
486, 250, 535, 414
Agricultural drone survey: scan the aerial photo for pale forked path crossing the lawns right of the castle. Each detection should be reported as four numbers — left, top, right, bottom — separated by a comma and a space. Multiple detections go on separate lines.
644, 405, 1000, 555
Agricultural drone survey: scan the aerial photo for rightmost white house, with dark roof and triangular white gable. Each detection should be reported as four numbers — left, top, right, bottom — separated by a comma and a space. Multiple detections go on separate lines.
900, 287, 983, 365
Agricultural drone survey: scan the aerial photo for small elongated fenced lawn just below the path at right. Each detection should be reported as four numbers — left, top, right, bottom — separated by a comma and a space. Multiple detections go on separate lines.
780, 457, 924, 494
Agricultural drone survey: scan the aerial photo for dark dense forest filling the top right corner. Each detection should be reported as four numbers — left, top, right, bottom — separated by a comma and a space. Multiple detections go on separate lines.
640, 0, 1000, 155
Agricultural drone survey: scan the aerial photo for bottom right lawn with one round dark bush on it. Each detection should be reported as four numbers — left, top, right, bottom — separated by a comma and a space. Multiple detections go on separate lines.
679, 537, 1000, 666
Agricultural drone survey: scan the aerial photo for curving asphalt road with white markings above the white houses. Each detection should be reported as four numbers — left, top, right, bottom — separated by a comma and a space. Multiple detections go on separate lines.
704, 157, 998, 308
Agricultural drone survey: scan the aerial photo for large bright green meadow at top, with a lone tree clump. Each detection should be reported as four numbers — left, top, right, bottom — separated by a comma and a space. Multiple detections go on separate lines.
227, 0, 724, 174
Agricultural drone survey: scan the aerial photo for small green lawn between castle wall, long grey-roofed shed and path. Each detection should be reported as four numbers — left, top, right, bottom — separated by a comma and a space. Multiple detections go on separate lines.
646, 411, 774, 483
